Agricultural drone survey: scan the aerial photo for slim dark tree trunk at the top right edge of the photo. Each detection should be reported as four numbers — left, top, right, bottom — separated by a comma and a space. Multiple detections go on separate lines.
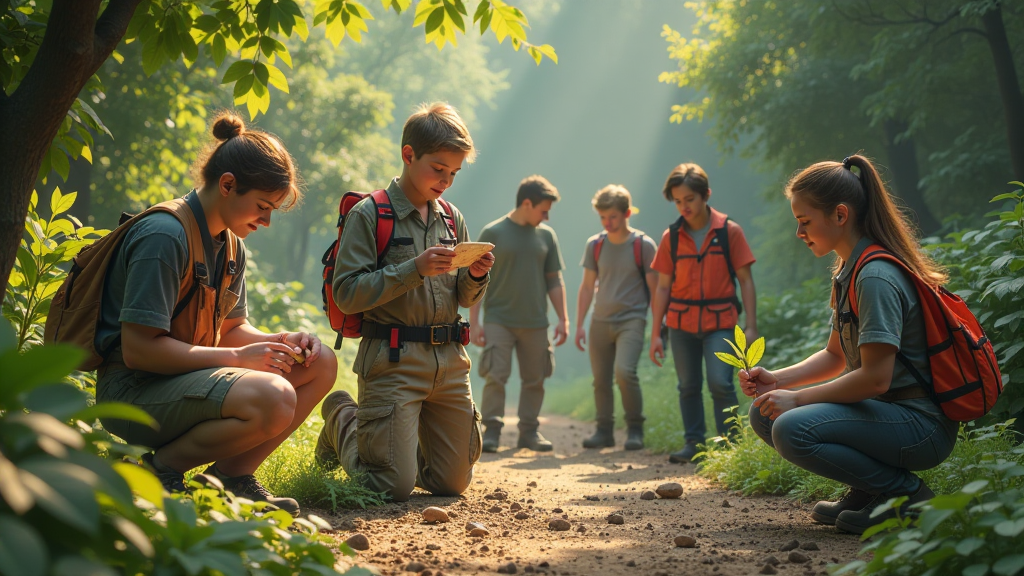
981, 3, 1024, 181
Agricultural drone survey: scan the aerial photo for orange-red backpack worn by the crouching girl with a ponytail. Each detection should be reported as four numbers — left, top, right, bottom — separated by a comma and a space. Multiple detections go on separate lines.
837, 244, 1002, 422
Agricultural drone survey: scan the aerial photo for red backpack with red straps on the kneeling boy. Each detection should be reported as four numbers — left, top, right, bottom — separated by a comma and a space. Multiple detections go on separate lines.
321, 190, 458, 349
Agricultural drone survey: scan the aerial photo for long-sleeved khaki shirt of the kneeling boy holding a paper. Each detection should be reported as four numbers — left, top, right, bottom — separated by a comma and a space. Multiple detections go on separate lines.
332, 179, 489, 326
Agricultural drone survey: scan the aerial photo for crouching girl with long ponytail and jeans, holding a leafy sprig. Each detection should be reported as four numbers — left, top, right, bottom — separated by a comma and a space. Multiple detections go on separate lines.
739, 155, 958, 534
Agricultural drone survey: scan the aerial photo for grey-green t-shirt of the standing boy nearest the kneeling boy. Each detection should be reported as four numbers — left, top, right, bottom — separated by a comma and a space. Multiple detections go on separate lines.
478, 216, 565, 328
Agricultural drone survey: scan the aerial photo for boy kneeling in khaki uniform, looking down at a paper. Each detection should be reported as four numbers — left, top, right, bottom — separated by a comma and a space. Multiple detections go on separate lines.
316, 104, 494, 501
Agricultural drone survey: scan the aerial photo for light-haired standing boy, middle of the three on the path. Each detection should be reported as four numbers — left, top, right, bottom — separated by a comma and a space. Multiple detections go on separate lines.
575, 184, 657, 450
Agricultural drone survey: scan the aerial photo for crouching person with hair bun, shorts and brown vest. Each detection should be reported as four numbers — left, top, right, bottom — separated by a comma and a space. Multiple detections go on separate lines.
95, 112, 337, 513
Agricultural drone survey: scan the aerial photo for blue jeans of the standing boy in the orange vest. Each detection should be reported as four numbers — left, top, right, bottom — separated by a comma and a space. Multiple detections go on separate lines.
669, 328, 738, 443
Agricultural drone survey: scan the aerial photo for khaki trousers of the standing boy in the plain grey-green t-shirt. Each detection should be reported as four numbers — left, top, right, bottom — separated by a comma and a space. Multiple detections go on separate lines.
479, 324, 555, 431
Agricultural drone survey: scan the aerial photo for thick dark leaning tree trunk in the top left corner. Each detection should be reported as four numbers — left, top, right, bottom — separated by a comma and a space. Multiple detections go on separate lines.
0, 0, 140, 293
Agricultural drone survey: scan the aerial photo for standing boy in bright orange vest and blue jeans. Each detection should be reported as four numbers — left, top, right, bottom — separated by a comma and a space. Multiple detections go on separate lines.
650, 164, 758, 463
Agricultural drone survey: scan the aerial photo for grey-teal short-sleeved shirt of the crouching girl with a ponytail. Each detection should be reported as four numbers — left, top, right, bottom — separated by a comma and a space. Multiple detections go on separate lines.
831, 238, 956, 426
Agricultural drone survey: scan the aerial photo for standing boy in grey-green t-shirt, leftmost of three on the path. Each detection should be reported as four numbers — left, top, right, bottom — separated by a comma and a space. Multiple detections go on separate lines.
470, 175, 569, 452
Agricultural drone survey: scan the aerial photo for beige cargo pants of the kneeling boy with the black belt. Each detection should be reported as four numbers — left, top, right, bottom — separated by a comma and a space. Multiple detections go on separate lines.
325, 338, 480, 501
